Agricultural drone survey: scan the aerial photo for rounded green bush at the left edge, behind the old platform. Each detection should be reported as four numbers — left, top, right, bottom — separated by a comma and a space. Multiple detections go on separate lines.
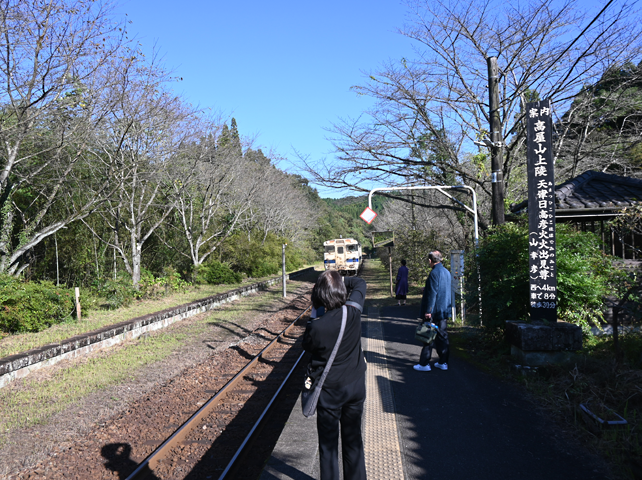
0, 275, 76, 333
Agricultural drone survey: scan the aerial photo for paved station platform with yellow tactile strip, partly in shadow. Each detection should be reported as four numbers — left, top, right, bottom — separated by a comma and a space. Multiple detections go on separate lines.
260, 305, 610, 480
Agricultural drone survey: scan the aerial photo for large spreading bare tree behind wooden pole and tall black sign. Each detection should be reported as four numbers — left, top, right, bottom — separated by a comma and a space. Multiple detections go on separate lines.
306, 0, 641, 227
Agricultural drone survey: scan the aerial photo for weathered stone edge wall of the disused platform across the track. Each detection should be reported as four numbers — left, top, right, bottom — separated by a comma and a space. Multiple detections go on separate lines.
0, 267, 314, 388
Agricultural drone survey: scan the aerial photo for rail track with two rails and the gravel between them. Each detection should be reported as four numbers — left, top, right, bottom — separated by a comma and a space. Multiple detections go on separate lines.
124, 307, 310, 480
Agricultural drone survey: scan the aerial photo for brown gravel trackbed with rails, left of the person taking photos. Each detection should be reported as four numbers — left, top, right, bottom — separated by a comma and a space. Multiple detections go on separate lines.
0, 285, 310, 480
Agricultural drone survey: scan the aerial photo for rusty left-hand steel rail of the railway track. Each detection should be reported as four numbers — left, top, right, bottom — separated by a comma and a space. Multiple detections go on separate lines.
125, 306, 312, 480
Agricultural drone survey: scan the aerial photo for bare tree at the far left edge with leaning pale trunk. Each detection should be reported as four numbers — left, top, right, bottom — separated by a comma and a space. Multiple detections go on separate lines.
0, 0, 131, 274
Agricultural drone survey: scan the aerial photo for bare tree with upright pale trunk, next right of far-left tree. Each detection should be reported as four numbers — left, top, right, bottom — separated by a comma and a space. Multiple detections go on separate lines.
87, 58, 198, 286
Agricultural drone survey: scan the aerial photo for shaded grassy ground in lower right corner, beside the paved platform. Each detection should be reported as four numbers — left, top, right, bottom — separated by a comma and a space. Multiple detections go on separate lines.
451, 327, 642, 480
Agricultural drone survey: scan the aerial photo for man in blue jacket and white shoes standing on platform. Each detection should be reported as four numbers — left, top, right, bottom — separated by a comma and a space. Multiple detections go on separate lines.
413, 251, 452, 372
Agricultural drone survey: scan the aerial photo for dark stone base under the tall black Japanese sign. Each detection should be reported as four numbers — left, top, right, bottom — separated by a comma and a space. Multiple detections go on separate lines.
506, 321, 582, 367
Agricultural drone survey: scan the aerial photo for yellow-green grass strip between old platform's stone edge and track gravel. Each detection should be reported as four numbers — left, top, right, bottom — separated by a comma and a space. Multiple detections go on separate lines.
0, 281, 312, 444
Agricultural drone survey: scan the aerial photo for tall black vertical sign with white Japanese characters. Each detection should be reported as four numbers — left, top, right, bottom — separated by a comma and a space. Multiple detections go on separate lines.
526, 100, 557, 322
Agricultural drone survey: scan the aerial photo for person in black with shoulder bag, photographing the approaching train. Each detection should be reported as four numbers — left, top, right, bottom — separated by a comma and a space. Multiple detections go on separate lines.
303, 270, 366, 480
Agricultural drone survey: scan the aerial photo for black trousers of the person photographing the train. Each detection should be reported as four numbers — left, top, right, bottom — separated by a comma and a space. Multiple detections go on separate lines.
317, 375, 366, 480
